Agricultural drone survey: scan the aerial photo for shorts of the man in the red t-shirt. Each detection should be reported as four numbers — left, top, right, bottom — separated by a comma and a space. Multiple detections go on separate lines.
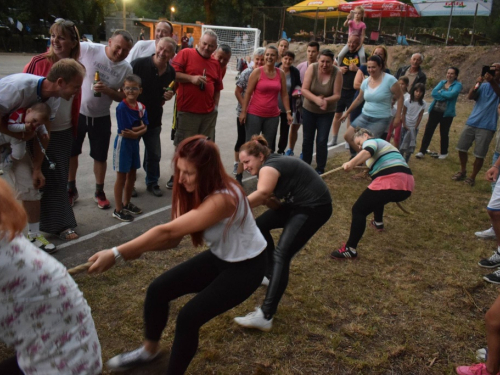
174, 110, 217, 146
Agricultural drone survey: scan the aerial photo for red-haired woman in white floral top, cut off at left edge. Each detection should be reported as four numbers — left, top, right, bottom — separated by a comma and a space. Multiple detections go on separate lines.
0, 179, 102, 375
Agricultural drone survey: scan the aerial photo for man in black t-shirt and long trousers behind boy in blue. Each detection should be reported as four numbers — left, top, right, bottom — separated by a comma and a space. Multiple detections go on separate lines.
132, 37, 177, 197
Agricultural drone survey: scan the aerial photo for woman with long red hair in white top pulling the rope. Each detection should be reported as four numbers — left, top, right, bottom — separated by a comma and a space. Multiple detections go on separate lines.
89, 135, 266, 375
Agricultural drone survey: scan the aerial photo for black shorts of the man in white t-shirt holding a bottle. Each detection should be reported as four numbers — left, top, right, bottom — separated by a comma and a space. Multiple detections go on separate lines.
71, 113, 111, 162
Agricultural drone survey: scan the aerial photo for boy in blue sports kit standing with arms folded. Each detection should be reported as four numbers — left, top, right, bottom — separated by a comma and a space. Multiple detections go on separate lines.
113, 74, 149, 221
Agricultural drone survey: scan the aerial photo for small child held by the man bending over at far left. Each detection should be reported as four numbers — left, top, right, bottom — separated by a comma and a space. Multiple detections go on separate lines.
0, 103, 50, 170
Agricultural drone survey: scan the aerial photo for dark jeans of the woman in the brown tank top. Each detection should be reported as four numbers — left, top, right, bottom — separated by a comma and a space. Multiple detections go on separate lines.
302, 108, 335, 173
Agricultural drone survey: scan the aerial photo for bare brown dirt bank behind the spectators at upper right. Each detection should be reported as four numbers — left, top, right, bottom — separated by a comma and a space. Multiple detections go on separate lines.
290, 43, 500, 93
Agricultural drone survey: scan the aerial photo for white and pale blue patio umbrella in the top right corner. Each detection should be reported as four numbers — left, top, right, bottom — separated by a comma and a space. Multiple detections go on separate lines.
412, 0, 493, 44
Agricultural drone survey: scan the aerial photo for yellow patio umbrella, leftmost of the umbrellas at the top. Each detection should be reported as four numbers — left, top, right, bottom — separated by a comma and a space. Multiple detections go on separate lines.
286, 0, 346, 41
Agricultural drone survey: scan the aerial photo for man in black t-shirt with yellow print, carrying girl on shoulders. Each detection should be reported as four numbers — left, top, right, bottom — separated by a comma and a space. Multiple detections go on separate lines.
328, 35, 361, 146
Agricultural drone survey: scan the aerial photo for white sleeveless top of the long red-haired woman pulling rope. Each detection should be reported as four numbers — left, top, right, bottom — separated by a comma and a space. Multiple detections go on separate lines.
203, 190, 267, 262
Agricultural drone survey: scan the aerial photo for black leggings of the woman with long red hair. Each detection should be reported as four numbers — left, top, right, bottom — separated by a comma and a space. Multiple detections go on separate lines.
144, 250, 266, 375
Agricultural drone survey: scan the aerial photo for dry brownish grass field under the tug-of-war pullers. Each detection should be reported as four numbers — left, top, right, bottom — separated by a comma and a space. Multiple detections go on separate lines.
0, 97, 498, 375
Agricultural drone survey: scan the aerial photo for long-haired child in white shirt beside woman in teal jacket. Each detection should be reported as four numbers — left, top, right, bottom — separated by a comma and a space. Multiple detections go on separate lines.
399, 83, 427, 163
